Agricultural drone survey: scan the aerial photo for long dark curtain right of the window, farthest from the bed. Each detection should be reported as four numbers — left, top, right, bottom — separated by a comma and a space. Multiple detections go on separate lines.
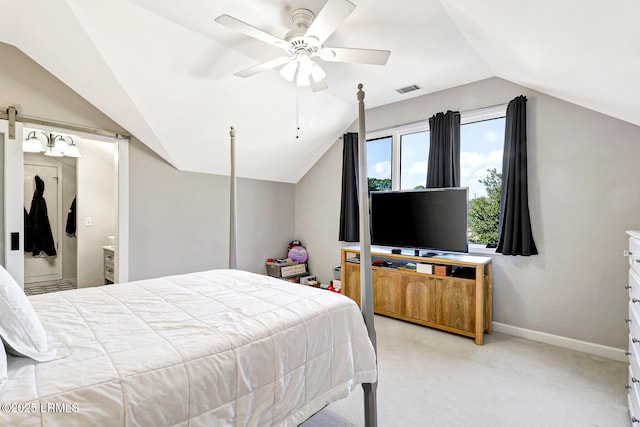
496, 95, 538, 256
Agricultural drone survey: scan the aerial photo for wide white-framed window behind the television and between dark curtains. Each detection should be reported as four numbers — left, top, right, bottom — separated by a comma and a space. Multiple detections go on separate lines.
367, 105, 507, 249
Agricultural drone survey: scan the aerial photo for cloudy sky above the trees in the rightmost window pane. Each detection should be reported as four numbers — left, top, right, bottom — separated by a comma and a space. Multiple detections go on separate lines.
460, 117, 505, 199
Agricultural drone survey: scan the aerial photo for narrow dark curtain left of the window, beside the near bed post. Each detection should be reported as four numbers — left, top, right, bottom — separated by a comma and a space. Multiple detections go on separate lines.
338, 133, 360, 242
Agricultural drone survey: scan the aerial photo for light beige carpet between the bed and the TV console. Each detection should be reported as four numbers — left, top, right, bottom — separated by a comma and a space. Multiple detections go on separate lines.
302, 316, 631, 427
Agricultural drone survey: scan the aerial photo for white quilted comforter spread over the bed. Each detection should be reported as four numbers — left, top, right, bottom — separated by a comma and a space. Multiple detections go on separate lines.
0, 270, 376, 427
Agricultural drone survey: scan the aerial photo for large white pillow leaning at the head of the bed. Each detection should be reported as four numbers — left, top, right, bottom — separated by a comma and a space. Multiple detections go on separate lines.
0, 266, 56, 362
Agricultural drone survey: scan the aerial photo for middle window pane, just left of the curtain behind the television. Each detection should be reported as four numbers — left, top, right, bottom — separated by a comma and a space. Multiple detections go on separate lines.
400, 131, 429, 190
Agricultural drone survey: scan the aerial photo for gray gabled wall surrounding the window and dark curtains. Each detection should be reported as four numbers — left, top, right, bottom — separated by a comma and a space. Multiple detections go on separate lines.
296, 78, 640, 348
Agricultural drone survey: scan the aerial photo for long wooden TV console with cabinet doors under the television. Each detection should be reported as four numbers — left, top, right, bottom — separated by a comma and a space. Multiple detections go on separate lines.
340, 246, 492, 345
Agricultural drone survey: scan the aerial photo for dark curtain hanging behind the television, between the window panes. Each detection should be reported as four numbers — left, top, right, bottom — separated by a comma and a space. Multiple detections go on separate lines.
427, 111, 460, 188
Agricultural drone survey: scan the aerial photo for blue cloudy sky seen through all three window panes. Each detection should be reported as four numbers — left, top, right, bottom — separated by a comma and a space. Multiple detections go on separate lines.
367, 118, 504, 198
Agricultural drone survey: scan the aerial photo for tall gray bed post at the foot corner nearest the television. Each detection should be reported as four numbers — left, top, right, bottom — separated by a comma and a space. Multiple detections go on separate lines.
358, 83, 378, 427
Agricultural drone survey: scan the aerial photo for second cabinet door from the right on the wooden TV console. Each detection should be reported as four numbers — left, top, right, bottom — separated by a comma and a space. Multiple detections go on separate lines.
400, 274, 436, 323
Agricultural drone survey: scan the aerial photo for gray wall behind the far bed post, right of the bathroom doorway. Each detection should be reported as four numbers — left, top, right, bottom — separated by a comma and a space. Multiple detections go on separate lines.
129, 141, 295, 280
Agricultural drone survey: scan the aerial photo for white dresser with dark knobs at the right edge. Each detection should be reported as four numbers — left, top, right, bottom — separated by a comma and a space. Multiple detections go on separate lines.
624, 231, 640, 426
